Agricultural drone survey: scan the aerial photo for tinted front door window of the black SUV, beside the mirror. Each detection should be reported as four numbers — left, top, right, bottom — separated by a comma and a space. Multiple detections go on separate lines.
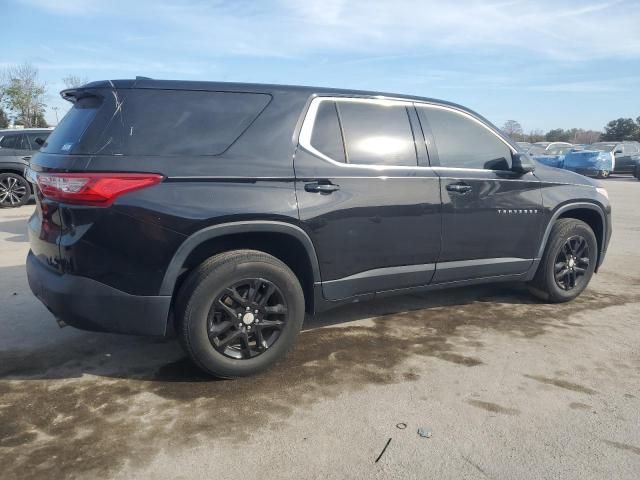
419, 107, 511, 170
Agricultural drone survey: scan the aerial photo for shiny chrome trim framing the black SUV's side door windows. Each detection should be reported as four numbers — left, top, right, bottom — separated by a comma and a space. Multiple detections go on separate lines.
298, 96, 517, 172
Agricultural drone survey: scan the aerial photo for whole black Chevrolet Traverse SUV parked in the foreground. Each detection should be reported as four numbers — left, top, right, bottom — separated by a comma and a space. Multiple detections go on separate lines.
27, 79, 611, 377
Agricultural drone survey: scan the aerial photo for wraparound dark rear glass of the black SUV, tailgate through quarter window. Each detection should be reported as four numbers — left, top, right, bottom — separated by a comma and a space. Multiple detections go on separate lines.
42, 89, 271, 155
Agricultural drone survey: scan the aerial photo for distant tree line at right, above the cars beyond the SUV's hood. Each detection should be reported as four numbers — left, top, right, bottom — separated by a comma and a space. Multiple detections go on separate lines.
502, 117, 640, 144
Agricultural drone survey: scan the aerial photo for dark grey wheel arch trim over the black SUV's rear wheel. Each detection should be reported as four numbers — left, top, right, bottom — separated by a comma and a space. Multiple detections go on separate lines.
159, 221, 320, 313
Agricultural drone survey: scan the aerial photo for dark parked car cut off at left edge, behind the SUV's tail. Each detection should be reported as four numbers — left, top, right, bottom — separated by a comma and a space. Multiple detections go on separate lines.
0, 128, 51, 207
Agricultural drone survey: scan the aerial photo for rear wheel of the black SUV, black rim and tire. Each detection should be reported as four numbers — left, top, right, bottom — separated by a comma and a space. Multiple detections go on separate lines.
176, 250, 305, 378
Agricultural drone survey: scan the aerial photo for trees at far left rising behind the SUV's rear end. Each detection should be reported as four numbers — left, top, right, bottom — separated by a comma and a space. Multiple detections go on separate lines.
0, 63, 87, 128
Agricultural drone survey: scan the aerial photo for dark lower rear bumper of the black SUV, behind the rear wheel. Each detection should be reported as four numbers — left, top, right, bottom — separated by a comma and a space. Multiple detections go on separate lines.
27, 252, 171, 336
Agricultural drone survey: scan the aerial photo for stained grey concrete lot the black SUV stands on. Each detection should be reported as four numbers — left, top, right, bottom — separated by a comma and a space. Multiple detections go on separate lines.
0, 177, 640, 479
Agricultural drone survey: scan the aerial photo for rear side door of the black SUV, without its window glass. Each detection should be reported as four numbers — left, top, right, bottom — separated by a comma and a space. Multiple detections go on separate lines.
295, 97, 441, 300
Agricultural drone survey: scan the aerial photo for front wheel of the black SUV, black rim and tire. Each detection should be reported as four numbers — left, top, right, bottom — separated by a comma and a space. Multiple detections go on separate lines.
529, 218, 598, 303
